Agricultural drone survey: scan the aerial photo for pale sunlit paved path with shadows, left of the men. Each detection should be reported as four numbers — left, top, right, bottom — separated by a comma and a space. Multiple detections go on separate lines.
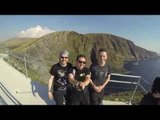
0, 59, 55, 105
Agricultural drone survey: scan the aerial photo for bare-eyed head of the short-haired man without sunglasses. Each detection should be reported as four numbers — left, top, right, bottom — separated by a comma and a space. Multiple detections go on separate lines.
98, 48, 108, 65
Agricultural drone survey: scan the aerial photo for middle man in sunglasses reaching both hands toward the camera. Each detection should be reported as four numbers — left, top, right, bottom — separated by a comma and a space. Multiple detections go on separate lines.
68, 55, 90, 105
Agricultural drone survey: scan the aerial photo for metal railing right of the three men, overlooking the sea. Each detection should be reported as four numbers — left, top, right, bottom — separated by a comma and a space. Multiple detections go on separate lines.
105, 73, 151, 104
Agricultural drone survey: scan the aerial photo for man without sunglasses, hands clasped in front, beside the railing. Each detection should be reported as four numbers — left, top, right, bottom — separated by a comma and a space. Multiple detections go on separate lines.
89, 49, 111, 105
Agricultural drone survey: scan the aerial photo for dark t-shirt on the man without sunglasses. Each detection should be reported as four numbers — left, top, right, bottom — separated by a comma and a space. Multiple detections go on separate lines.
90, 64, 111, 85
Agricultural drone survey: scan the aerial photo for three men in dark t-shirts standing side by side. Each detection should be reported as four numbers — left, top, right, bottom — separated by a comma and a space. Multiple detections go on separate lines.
48, 49, 111, 105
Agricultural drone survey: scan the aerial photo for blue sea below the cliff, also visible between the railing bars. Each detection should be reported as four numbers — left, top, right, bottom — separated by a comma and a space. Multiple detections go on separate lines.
105, 58, 160, 94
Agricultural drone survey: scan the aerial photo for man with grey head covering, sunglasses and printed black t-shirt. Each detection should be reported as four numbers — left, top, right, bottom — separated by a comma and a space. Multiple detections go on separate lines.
48, 51, 72, 105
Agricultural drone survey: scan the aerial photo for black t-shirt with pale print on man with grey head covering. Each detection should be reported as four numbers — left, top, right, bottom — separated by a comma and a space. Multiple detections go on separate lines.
50, 63, 72, 90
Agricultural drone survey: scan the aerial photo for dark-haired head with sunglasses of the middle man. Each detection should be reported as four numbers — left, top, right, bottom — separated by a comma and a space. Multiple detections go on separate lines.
76, 55, 87, 70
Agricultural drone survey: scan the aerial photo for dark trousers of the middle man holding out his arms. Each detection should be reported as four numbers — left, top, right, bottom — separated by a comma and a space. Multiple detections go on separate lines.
71, 90, 90, 105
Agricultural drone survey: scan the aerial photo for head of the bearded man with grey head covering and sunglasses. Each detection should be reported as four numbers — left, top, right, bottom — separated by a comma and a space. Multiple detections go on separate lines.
59, 50, 69, 66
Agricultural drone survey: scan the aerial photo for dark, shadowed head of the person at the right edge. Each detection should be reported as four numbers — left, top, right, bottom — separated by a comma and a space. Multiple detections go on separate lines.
152, 77, 160, 93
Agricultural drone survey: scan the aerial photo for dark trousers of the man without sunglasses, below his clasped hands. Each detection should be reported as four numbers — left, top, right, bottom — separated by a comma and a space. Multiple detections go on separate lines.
90, 91, 104, 105
